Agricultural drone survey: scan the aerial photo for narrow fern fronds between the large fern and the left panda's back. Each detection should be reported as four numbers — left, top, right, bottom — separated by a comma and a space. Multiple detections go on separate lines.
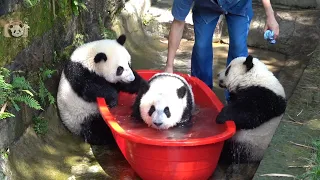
38, 68, 57, 107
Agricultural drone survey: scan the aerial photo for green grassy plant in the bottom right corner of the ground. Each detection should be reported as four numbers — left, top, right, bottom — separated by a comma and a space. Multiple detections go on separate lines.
298, 140, 320, 180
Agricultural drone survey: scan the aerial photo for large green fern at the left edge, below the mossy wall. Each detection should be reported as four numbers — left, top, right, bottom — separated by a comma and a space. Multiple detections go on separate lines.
0, 67, 42, 119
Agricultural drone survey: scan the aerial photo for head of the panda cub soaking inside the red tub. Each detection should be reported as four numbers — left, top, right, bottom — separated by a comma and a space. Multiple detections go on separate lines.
140, 78, 187, 129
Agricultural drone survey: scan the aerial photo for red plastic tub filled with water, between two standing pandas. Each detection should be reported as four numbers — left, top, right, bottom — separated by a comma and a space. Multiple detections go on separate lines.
97, 70, 236, 180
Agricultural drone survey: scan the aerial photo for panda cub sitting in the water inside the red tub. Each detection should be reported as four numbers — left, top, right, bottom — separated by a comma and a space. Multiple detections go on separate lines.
132, 73, 194, 129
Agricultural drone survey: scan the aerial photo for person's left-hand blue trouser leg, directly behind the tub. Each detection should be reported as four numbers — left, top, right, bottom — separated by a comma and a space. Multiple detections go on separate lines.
191, 13, 219, 89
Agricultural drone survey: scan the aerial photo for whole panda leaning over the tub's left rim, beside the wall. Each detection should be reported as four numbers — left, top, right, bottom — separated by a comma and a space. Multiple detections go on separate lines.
57, 35, 147, 145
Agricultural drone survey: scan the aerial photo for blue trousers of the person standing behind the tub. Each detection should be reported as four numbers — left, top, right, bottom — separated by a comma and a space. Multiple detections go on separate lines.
191, 10, 253, 100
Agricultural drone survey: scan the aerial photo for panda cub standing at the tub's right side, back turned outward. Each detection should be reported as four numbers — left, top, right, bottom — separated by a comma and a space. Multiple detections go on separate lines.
216, 55, 286, 163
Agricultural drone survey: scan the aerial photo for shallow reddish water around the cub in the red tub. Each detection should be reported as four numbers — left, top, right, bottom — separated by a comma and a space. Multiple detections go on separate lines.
110, 95, 224, 140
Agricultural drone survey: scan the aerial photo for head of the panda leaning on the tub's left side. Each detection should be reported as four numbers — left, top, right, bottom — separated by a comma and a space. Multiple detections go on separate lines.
71, 35, 135, 83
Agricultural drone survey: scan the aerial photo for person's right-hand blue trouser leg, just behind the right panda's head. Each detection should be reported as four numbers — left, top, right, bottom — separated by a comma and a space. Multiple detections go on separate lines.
225, 10, 253, 101
